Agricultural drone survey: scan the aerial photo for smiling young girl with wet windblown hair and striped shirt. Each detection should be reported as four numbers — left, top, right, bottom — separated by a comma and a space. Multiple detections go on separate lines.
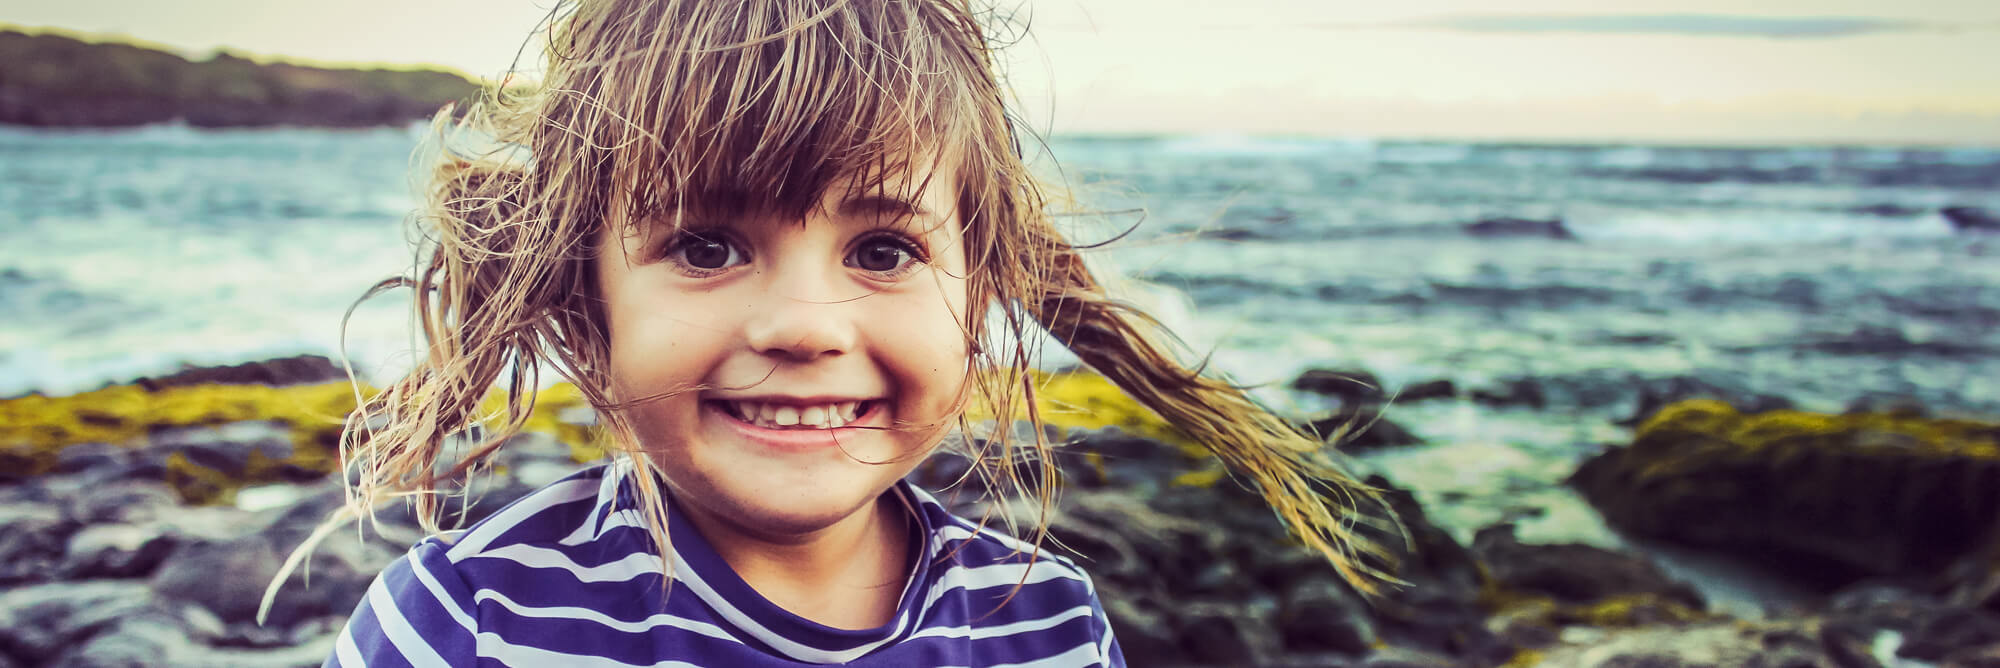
328, 0, 1392, 666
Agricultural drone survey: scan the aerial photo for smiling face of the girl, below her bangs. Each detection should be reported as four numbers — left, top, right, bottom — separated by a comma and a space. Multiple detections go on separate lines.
596, 174, 968, 536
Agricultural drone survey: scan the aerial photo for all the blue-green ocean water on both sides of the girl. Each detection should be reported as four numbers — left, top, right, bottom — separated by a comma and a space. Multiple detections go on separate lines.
0, 126, 2000, 596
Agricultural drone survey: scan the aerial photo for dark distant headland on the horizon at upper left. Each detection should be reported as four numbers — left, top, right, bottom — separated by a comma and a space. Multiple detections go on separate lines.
0, 30, 480, 128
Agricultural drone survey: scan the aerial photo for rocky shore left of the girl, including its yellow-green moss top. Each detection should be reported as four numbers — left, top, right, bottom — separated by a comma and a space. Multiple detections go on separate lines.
0, 358, 600, 668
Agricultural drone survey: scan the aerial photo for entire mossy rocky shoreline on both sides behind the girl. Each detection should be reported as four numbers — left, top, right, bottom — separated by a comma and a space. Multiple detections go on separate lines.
0, 358, 2000, 668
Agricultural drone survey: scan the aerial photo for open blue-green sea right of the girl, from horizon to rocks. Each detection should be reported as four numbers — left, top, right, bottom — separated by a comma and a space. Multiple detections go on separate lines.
1056, 138, 2000, 412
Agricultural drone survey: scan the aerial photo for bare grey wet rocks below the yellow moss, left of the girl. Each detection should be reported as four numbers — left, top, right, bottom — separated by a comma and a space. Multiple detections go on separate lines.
0, 430, 560, 666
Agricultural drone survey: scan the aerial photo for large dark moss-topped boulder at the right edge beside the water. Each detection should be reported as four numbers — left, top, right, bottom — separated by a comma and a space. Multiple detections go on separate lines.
1570, 400, 2000, 584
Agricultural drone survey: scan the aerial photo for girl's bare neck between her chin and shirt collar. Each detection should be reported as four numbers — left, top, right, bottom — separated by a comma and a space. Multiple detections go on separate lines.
682, 494, 914, 630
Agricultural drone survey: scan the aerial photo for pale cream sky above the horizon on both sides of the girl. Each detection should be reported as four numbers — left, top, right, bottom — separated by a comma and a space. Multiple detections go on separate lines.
0, 0, 2000, 146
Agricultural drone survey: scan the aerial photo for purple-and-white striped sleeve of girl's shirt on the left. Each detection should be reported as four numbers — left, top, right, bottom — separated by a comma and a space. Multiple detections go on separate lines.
324, 540, 478, 668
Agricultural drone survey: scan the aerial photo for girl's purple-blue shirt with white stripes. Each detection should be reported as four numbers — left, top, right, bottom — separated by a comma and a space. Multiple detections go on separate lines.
326, 464, 1124, 668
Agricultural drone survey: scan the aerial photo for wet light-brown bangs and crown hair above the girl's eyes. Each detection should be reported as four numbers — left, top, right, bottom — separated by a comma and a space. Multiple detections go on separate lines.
568, 0, 990, 235
